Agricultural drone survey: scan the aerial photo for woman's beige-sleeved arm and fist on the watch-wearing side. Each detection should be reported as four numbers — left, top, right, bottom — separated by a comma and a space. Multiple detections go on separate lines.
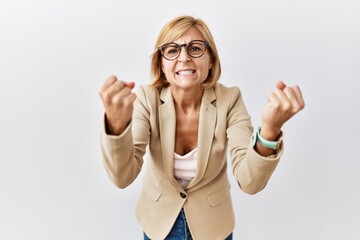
227, 82, 304, 194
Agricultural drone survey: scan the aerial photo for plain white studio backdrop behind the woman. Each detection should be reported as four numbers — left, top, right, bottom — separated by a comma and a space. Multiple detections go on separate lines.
0, 0, 360, 240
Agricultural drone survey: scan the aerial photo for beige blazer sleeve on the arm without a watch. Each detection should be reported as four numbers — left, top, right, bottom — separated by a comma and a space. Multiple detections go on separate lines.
100, 85, 150, 188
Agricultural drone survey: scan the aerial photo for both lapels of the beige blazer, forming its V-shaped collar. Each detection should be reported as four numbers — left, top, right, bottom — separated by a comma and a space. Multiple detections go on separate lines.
159, 87, 217, 190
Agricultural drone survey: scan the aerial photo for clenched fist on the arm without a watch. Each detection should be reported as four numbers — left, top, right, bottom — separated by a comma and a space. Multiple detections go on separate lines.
99, 76, 136, 135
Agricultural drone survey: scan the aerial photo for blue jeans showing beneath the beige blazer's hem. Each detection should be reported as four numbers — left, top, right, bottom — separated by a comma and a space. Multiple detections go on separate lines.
144, 209, 232, 240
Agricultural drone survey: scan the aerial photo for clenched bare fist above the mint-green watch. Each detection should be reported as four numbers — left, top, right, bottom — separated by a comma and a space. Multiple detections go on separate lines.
261, 81, 305, 140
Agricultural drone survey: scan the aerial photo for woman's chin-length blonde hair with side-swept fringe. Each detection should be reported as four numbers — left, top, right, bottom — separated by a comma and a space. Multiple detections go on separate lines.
150, 16, 221, 89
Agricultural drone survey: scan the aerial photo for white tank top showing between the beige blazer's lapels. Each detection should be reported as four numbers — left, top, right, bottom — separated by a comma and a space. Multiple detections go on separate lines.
174, 148, 198, 188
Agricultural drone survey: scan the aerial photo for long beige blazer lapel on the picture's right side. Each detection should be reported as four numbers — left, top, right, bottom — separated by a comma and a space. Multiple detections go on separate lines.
186, 88, 217, 188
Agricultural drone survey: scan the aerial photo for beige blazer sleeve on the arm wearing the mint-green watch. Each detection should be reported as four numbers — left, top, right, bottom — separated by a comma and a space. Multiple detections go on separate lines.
226, 88, 283, 194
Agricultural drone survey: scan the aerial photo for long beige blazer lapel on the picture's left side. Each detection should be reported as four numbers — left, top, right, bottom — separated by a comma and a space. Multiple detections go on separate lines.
159, 87, 181, 189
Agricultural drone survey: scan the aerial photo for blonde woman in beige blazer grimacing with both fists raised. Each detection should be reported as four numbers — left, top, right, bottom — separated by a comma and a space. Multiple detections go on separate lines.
99, 16, 304, 240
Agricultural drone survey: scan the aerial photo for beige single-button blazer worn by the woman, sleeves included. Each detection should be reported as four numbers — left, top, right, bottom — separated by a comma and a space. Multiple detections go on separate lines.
101, 83, 282, 240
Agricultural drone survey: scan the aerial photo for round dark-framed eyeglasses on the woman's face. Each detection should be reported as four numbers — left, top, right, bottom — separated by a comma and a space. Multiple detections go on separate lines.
158, 40, 209, 61
